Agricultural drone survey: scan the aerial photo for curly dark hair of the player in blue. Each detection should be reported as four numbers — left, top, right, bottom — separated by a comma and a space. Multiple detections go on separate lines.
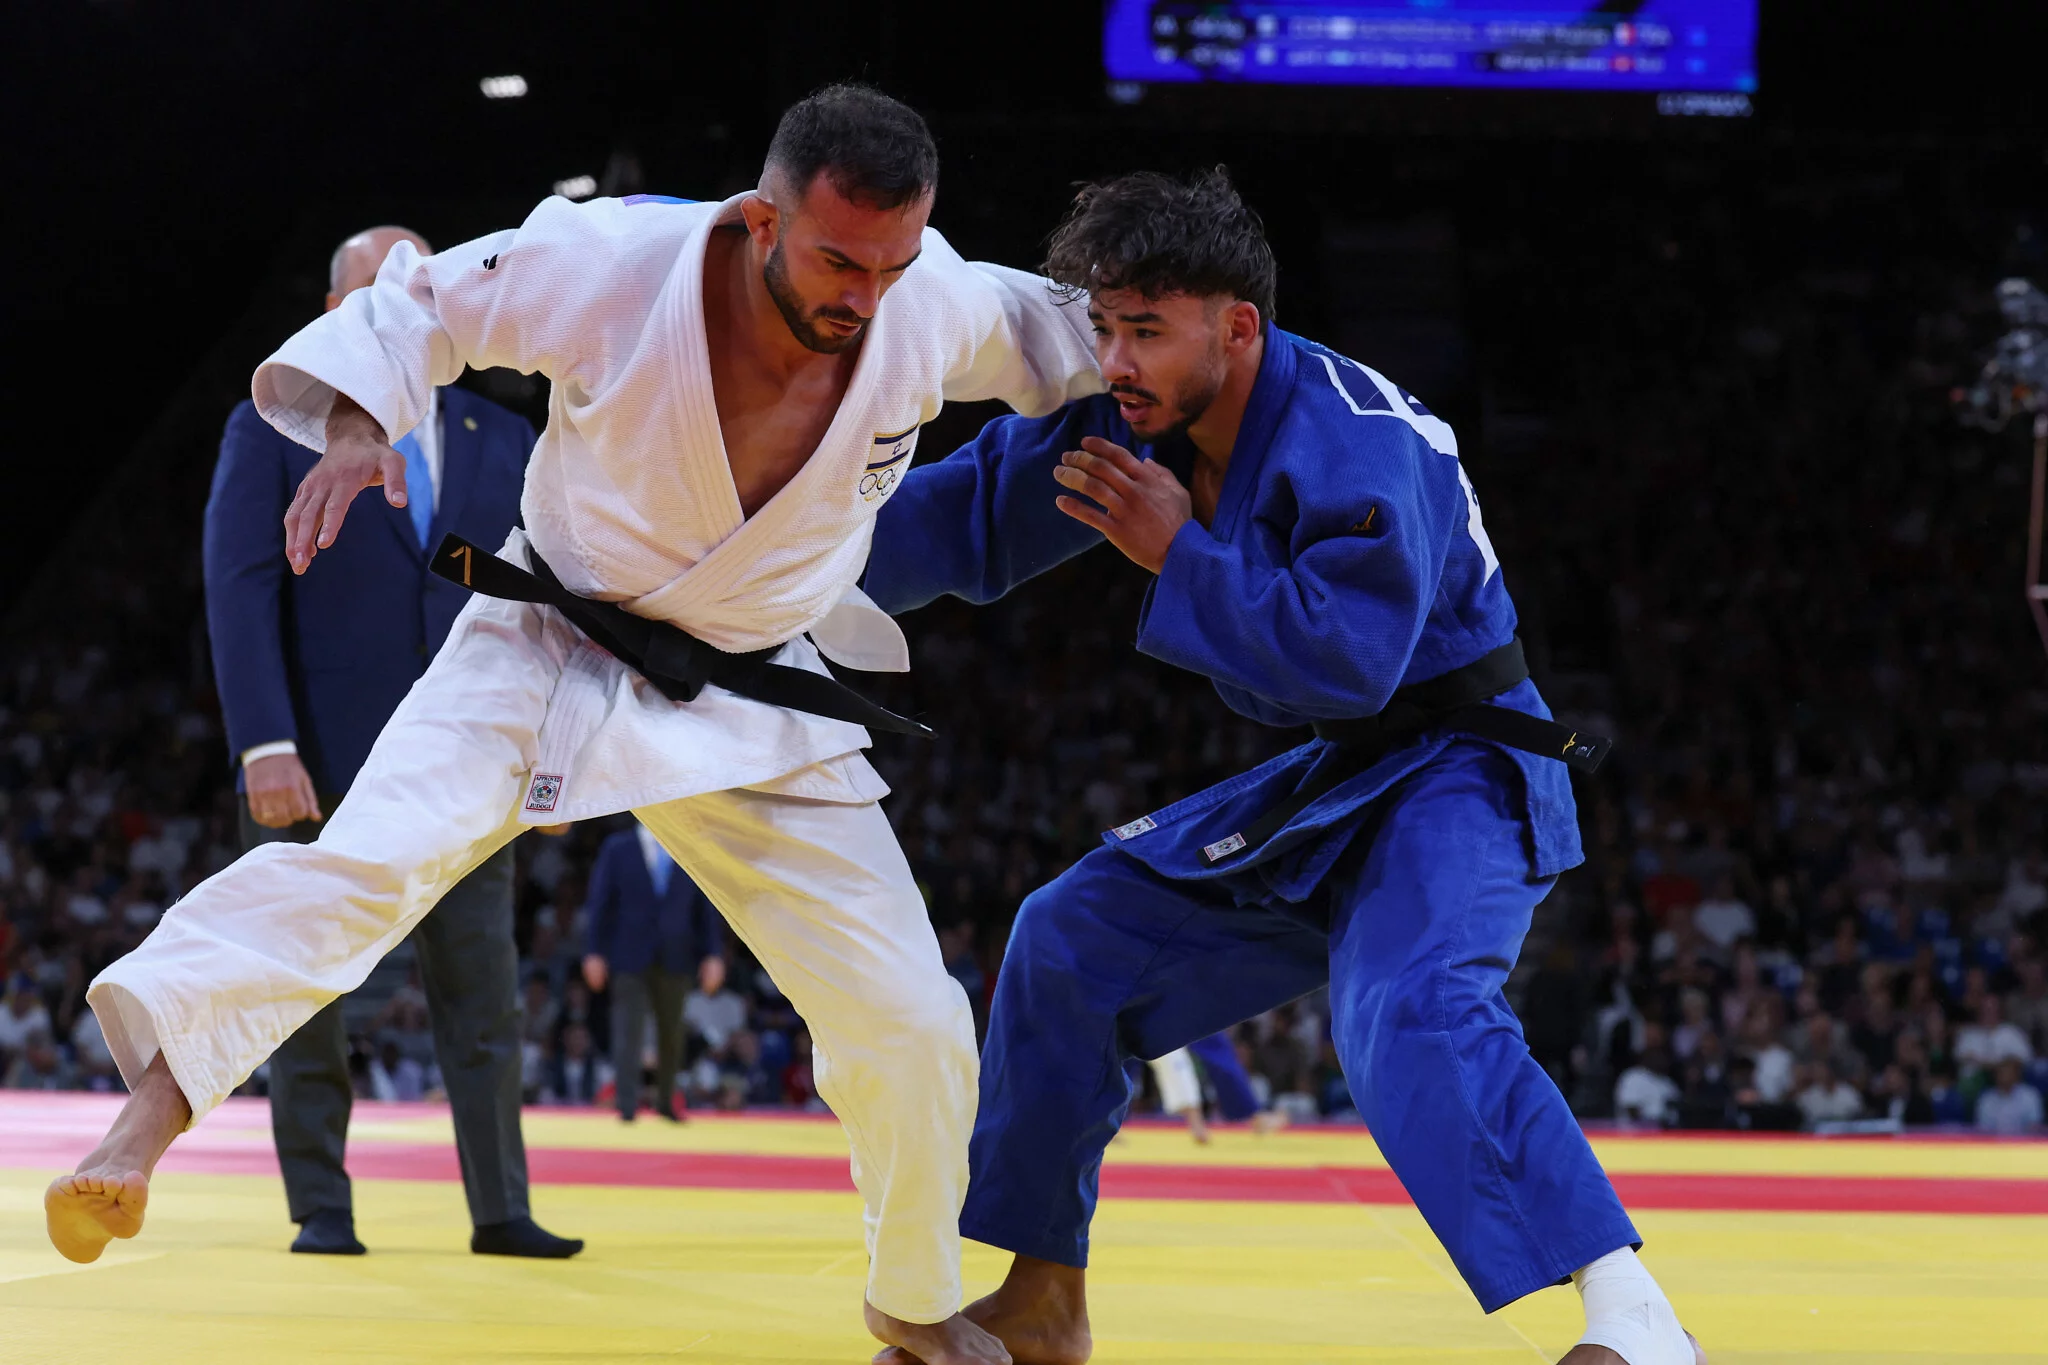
1044, 166, 1280, 319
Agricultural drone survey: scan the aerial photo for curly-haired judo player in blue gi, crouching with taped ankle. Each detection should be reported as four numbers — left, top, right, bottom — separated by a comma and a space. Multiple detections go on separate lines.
864, 170, 1704, 1365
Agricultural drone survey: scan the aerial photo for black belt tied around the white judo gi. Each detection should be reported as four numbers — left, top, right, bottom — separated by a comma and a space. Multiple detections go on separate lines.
444, 534, 932, 737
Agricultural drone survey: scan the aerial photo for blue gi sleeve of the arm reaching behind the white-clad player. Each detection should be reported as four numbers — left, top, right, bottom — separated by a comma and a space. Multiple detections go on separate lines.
860, 395, 1130, 614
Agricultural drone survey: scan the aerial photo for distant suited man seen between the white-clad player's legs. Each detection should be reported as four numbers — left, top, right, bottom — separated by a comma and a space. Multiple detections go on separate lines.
584, 821, 725, 1124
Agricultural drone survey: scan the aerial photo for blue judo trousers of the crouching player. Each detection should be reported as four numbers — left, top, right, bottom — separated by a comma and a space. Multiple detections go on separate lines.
961, 743, 1640, 1312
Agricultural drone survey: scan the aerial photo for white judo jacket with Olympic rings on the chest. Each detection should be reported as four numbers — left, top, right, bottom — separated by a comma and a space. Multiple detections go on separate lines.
254, 196, 1104, 825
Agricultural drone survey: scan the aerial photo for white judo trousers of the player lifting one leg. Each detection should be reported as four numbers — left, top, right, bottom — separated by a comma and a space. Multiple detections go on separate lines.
88, 581, 979, 1322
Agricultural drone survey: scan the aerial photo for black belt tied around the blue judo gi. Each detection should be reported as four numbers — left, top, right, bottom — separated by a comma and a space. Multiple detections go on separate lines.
1202, 641, 1614, 866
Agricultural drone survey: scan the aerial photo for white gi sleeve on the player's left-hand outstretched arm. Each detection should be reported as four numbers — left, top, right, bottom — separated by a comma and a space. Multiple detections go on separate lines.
252, 199, 643, 450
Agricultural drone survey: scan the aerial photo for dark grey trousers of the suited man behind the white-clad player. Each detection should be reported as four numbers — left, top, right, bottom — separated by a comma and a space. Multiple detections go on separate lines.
242, 798, 528, 1226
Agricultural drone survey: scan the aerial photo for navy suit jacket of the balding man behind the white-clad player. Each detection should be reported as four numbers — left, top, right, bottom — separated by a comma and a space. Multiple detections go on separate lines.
205, 389, 535, 794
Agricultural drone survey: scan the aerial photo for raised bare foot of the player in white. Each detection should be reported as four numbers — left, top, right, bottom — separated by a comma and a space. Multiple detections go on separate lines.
43, 1054, 193, 1263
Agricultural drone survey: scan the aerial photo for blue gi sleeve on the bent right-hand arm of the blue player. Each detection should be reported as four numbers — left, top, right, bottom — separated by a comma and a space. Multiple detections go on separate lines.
1139, 422, 1458, 722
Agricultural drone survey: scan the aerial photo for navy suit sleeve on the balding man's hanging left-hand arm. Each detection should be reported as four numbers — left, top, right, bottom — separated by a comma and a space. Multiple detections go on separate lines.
201, 403, 299, 759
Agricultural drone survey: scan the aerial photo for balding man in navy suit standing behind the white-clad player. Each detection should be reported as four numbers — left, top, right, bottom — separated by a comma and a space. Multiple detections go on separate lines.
205, 227, 584, 1257
